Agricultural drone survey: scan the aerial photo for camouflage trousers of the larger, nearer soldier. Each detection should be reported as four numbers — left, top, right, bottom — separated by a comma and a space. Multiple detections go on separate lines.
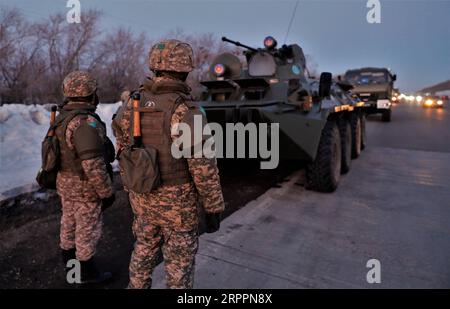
128, 216, 198, 289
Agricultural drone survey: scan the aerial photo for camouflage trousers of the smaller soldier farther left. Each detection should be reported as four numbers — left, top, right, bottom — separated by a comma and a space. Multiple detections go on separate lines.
60, 197, 102, 261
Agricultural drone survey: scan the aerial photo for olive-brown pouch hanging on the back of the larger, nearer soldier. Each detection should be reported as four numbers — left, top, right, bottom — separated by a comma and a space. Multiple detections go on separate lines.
119, 145, 161, 193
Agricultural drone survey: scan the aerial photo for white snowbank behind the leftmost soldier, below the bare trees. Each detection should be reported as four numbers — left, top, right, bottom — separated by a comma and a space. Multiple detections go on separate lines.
0, 102, 121, 200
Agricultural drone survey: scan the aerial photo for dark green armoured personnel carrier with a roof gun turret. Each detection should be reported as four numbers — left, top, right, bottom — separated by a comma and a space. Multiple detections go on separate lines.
198, 36, 364, 192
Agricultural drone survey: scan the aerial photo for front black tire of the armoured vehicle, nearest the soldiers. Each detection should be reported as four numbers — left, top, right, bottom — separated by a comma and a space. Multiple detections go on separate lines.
305, 121, 342, 192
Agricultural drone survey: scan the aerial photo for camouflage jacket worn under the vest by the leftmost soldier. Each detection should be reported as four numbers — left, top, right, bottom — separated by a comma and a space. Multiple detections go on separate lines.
56, 102, 114, 201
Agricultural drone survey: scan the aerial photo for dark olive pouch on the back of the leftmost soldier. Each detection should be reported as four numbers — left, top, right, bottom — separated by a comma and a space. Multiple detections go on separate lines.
36, 132, 60, 189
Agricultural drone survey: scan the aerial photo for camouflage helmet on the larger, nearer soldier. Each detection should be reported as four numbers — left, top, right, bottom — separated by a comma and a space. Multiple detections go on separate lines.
149, 40, 194, 73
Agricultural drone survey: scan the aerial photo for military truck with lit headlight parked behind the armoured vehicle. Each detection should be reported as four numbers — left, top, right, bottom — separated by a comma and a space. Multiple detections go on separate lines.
345, 67, 397, 122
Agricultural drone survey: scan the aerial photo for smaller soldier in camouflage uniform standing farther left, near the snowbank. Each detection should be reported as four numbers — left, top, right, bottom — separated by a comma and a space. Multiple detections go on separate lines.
55, 71, 114, 283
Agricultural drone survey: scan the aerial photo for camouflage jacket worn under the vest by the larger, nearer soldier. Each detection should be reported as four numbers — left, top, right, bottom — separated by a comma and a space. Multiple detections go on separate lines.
112, 78, 225, 230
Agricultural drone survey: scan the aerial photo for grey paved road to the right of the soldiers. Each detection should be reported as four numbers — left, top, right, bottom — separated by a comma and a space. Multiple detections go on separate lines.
155, 102, 450, 288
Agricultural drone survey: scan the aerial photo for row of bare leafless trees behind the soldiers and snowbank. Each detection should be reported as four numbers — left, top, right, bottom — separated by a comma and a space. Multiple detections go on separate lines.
0, 9, 251, 103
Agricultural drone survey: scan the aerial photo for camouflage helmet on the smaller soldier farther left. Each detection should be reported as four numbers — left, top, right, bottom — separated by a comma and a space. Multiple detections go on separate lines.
63, 71, 97, 98
